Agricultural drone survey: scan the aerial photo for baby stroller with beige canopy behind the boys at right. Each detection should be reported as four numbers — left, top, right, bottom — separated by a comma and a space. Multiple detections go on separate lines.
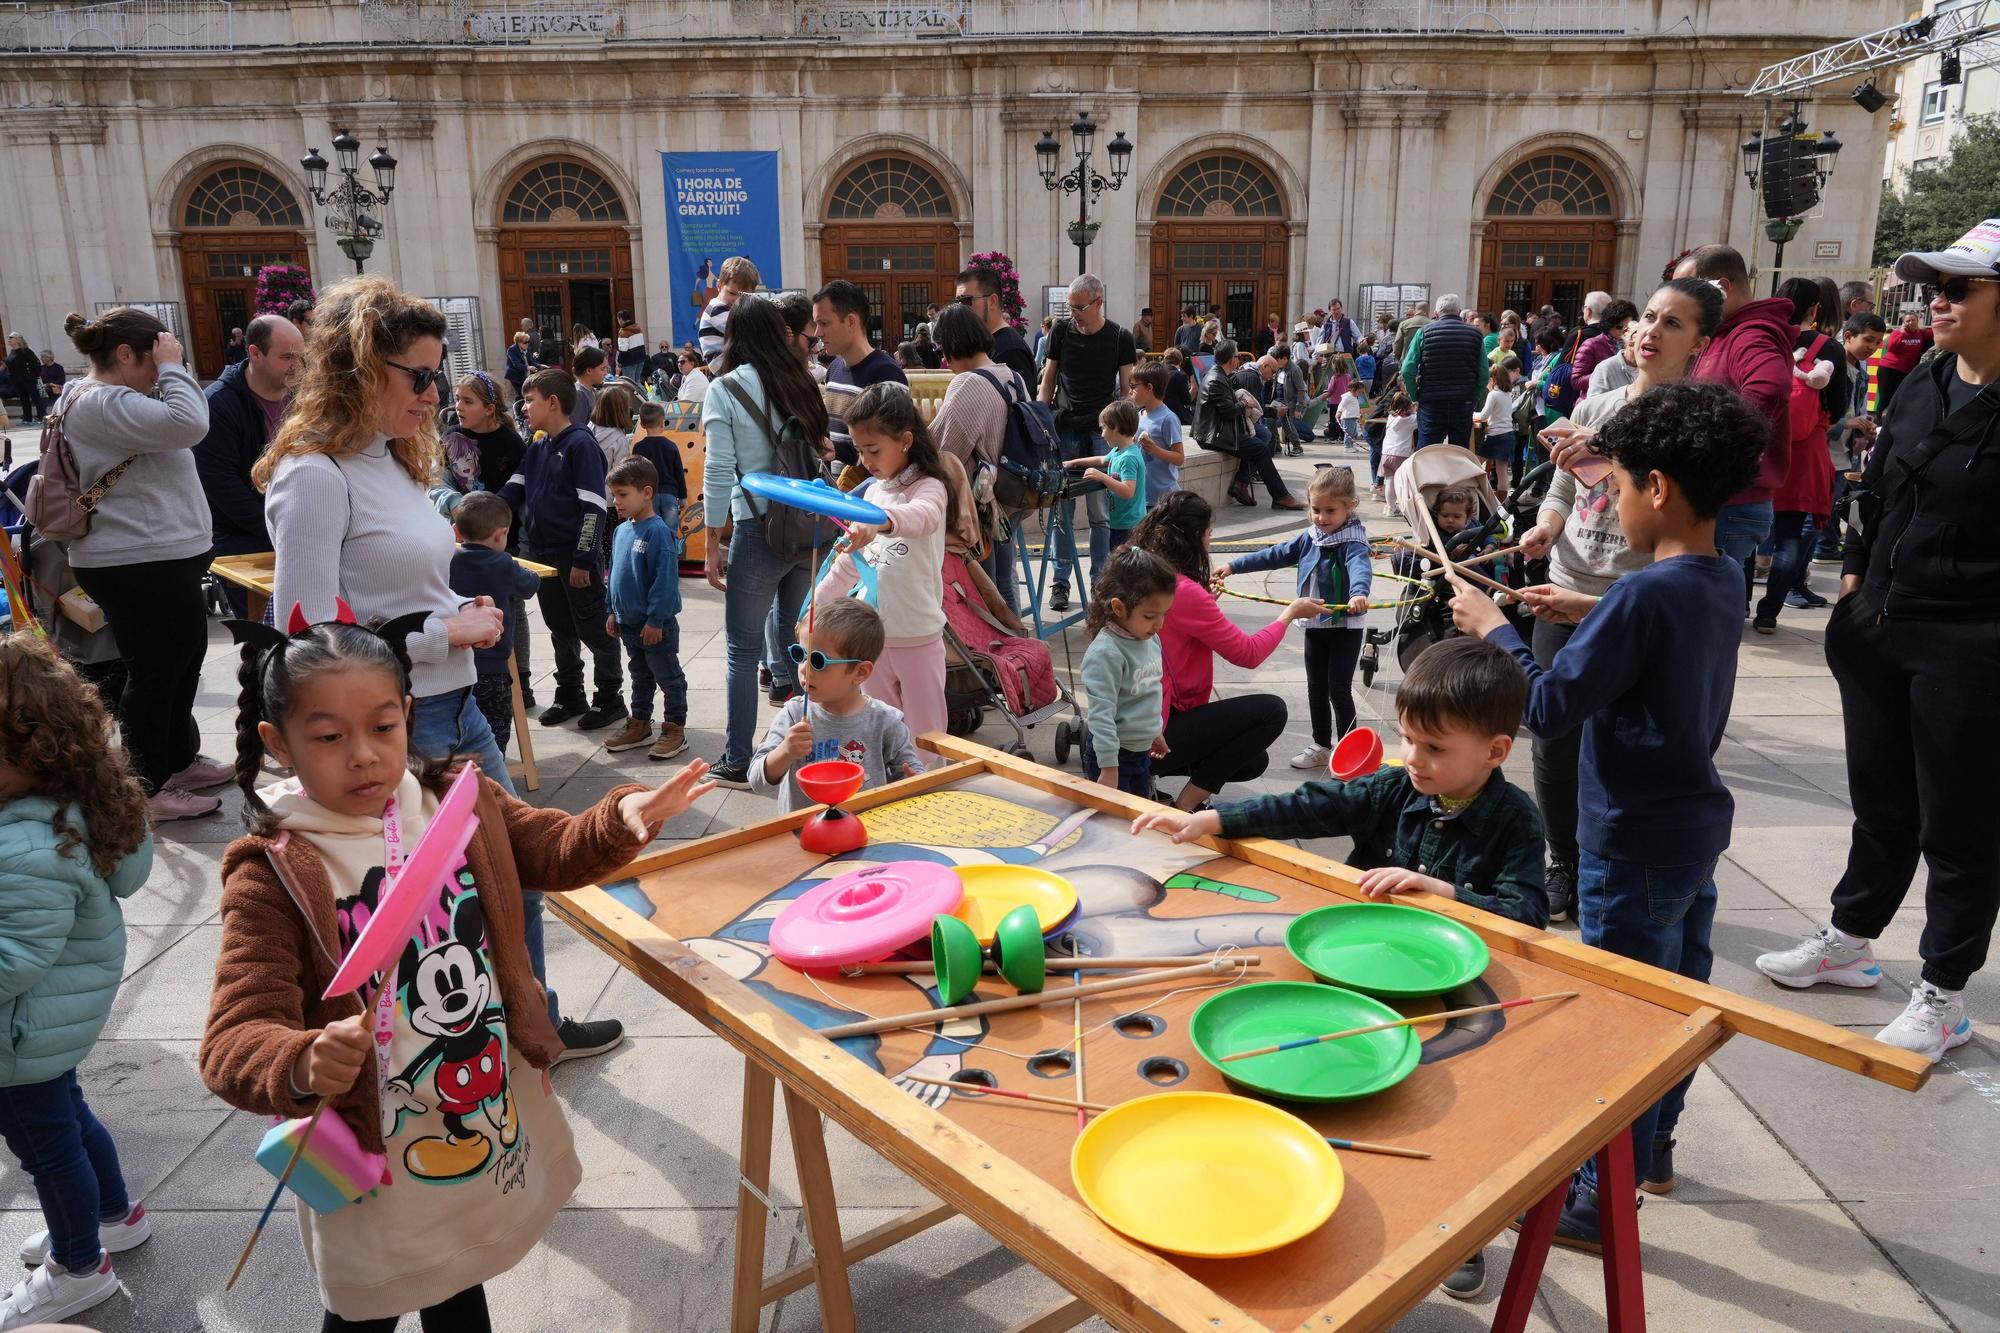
1360, 444, 1518, 685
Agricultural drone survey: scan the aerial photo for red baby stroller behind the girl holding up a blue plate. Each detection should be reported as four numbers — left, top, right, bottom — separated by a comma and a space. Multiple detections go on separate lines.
944, 552, 1084, 765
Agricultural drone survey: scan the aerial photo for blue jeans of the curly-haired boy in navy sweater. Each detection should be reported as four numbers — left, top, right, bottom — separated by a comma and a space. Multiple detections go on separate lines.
1576, 849, 1716, 1183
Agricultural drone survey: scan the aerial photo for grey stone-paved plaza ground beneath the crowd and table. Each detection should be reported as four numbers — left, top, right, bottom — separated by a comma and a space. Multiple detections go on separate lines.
0, 432, 2000, 1333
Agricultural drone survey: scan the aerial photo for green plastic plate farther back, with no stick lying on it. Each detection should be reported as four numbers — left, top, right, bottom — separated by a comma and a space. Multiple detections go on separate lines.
1284, 903, 1490, 999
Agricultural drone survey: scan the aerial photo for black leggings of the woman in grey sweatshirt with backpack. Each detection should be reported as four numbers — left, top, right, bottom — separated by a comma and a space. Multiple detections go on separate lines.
76, 552, 208, 793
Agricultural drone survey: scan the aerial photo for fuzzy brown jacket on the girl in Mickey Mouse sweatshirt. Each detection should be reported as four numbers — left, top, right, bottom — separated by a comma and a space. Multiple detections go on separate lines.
200, 779, 646, 1153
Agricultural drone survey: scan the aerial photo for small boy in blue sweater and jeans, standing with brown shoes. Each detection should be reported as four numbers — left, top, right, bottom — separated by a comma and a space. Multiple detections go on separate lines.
604, 454, 688, 759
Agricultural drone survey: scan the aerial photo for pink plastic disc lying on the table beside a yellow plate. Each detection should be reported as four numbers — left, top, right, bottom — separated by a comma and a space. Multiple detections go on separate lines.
770, 861, 966, 971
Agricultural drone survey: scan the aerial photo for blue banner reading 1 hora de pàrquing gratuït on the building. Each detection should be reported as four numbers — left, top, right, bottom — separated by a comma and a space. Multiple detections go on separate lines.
660, 152, 784, 342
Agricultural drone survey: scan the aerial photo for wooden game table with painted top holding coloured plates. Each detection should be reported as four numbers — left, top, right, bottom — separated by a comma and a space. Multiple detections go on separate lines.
548, 735, 1930, 1333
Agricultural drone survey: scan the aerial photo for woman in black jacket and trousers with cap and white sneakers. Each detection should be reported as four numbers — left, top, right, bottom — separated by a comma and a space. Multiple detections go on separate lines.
1756, 222, 2000, 1061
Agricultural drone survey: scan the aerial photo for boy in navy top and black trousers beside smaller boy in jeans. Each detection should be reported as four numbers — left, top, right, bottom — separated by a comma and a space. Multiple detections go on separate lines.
500, 370, 626, 731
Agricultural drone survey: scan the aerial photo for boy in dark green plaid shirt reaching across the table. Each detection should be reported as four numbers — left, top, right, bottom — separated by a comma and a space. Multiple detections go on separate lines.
1132, 638, 1548, 1301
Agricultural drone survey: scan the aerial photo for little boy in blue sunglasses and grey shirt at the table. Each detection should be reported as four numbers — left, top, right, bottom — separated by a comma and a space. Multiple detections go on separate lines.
750, 596, 924, 815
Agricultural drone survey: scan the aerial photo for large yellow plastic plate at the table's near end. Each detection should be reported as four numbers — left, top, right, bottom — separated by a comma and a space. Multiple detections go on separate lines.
1070, 1093, 1344, 1259
